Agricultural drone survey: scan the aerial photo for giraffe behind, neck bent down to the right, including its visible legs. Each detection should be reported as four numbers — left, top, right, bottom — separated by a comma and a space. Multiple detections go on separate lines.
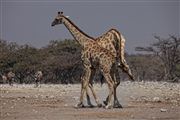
86, 29, 134, 108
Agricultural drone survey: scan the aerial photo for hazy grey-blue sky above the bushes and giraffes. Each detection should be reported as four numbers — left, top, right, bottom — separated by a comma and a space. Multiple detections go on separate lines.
0, 0, 180, 53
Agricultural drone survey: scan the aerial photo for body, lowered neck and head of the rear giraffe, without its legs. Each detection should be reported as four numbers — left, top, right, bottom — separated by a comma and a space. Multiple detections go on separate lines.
95, 28, 134, 80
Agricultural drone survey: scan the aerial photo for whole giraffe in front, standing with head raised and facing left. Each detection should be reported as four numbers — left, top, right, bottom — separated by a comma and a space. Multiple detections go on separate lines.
51, 12, 116, 108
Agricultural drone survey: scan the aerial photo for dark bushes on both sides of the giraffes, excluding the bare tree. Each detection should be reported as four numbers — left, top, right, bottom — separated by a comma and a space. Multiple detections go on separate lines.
0, 35, 180, 84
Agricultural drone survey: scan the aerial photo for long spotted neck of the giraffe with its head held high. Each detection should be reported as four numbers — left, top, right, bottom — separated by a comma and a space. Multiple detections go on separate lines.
64, 18, 94, 46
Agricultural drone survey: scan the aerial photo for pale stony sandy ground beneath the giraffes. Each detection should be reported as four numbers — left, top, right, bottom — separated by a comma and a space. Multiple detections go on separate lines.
0, 82, 180, 120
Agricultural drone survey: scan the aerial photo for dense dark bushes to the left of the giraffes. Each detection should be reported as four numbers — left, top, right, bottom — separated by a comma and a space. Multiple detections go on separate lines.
0, 40, 82, 83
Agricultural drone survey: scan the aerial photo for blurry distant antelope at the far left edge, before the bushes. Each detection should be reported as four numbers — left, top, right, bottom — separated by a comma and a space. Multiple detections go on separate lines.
2, 71, 15, 86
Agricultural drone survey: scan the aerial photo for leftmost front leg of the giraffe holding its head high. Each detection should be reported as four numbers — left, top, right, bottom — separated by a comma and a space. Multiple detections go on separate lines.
76, 65, 91, 107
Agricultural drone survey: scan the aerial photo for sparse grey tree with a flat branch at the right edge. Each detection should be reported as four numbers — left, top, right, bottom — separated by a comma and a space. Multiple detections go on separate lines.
136, 35, 180, 81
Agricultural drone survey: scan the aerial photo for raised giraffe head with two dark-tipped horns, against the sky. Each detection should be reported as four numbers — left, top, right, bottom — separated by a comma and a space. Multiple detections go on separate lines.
51, 12, 66, 26
